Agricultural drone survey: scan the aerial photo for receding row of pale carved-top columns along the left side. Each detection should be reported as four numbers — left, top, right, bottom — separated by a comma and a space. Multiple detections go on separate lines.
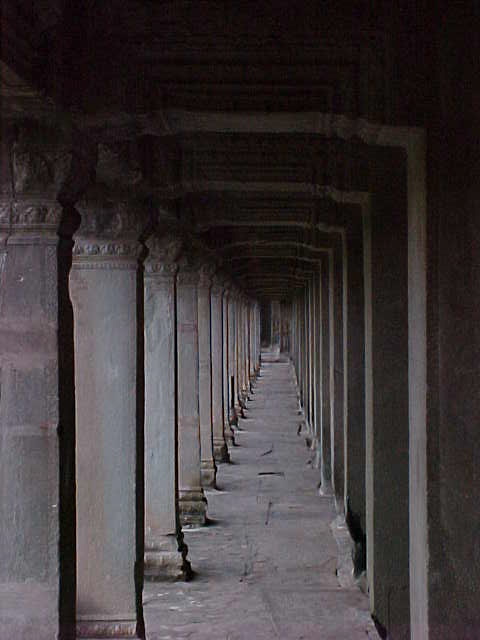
0, 182, 260, 640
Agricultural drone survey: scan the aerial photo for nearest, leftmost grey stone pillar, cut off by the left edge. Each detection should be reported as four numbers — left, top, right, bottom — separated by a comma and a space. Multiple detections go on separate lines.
0, 122, 72, 640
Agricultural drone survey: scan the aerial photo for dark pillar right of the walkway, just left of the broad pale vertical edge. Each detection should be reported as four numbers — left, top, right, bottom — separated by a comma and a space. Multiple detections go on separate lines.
364, 153, 410, 639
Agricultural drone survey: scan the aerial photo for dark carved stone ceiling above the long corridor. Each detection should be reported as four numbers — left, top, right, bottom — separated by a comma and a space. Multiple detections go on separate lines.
2, 0, 426, 298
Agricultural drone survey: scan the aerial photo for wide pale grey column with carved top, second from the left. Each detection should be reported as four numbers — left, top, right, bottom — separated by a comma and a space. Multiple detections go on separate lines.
70, 196, 139, 638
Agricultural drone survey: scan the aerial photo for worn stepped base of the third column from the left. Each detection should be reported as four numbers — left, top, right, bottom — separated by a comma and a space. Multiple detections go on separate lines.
144, 533, 192, 582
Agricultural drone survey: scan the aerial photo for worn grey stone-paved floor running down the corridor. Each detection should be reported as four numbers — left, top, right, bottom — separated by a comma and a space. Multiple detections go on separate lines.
144, 354, 378, 640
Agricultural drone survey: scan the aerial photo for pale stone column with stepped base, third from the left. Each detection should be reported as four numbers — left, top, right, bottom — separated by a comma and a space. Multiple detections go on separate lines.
144, 236, 190, 580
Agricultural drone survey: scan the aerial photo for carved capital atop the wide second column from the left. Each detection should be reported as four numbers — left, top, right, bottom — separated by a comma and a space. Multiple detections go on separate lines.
73, 193, 147, 268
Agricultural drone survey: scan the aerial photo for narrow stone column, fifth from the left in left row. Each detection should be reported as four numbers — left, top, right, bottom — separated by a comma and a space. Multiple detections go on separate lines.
198, 265, 217, 487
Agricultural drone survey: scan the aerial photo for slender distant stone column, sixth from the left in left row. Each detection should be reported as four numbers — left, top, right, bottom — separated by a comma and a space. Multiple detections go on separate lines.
210, 277, 230, 462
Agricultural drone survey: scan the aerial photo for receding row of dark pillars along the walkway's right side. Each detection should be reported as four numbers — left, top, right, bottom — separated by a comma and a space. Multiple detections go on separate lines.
283, 209, 410, 638
